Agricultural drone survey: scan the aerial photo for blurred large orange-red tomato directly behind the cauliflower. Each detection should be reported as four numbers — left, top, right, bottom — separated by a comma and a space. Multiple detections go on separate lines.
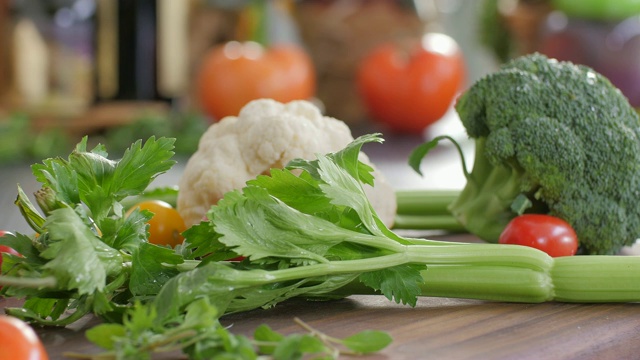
197, 41, 315, 120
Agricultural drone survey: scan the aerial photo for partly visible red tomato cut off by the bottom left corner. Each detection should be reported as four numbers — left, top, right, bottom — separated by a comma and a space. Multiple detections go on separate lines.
0, 315, 49, 360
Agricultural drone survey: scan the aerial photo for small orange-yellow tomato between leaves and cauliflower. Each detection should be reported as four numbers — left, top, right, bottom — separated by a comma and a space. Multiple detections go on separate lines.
129, 200, 187, 247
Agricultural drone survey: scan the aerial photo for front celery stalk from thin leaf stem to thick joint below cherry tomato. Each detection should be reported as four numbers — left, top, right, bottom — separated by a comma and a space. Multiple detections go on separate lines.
201, 244, 554, 302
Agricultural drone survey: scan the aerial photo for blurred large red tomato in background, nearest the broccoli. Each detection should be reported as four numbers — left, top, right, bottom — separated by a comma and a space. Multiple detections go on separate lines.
357, 33, 465, 133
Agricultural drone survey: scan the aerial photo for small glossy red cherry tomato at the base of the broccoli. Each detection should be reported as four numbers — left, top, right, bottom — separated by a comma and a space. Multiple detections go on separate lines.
498, 214, 578, 257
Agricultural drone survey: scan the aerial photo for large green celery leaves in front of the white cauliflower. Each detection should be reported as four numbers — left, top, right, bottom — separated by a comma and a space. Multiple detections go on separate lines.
176, 134, 424, 311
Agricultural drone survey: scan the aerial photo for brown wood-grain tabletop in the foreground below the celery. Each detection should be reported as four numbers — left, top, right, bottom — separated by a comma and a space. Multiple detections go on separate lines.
0, 295, 640, 360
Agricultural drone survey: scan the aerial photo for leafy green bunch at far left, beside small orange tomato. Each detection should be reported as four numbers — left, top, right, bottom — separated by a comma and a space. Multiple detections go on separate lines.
0, 137, 175, 326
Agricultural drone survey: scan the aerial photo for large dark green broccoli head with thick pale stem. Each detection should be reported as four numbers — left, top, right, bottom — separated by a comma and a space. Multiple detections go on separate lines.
442, 54, 640, 254
